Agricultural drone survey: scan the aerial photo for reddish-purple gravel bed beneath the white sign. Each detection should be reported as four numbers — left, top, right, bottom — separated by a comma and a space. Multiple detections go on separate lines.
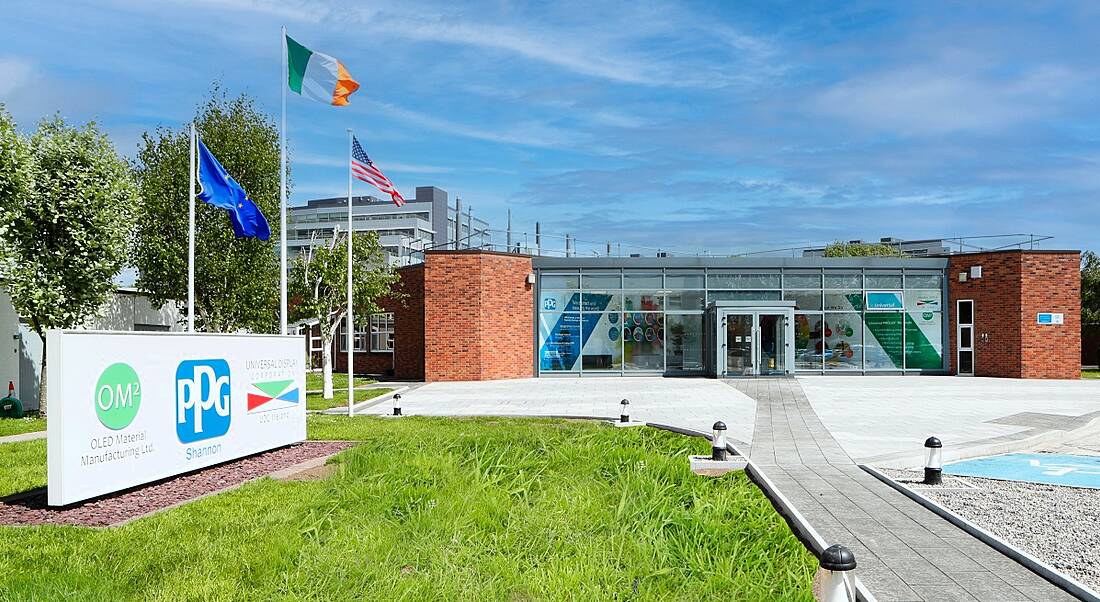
0, 441, 355, 526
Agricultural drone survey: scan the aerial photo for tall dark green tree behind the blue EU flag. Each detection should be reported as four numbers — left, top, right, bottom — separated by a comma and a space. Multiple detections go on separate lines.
133, 87, 279, 332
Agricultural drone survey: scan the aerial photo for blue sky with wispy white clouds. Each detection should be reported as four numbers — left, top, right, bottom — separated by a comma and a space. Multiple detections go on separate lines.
0, 0, 1100, 254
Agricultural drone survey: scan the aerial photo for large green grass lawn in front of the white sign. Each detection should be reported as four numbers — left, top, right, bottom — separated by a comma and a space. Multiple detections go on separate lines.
0, 416, 816, 601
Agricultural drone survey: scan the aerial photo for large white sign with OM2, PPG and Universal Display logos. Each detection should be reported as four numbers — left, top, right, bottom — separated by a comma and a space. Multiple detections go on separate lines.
46, 330, 306, 505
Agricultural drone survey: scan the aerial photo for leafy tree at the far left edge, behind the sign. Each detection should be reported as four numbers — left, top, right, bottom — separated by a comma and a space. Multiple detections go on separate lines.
0, 113, 140, 415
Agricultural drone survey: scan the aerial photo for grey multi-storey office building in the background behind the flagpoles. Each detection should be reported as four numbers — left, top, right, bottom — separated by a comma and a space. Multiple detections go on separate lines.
287, 186, 492, 265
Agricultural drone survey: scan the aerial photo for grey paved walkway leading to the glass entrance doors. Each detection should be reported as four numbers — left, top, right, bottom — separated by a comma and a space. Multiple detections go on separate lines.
729, 379, 1075, 602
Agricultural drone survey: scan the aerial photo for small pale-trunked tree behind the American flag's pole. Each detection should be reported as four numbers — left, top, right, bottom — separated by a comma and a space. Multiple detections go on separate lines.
289, 230, 402, 399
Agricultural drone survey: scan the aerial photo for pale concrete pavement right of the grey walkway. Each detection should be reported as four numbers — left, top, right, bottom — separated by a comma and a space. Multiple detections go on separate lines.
798, 376, 1100, 468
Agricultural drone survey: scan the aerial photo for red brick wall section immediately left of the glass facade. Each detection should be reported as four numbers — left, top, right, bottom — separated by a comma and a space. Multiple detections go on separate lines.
424, 251, 535, 382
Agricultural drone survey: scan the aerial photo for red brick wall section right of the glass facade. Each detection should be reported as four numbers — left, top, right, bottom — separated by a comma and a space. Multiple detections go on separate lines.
944, 250, 1081, 379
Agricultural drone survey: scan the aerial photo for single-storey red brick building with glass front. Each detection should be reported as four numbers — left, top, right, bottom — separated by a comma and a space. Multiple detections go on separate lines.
321, 250, 1081, 382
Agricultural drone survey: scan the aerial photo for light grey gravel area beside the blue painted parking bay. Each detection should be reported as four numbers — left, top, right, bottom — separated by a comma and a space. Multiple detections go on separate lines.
882, 470, 1100, 591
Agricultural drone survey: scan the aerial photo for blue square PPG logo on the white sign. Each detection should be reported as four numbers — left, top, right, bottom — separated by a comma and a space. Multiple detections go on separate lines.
176, 360, 231, 444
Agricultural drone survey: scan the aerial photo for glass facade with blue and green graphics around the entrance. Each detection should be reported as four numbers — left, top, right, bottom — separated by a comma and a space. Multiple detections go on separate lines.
537, 267, 945, 374
